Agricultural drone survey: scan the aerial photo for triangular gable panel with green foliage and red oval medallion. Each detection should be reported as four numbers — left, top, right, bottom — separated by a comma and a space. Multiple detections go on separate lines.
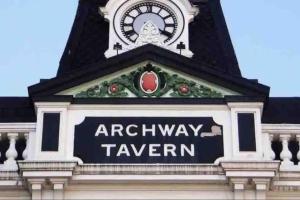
57, 61, 240, 98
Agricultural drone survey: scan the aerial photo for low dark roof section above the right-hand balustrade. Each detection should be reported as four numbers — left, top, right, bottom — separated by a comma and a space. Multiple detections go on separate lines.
262, 97, 300, 124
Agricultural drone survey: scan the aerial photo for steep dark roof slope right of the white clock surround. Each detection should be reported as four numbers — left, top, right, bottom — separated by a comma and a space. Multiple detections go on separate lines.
189, 0, 241, 76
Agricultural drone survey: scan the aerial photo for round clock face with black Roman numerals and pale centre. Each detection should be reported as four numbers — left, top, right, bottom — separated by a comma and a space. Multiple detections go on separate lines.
121, 2, 178, 43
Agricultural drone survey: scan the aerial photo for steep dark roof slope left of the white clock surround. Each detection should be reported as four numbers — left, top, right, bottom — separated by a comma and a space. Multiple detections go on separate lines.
58, 0, 109, 75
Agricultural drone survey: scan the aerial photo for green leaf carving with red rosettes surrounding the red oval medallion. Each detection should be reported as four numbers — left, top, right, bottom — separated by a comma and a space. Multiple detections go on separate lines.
75, 64, 223, 98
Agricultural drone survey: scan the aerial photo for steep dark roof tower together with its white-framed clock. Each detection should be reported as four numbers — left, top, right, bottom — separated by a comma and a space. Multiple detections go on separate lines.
58, 0, 241, 77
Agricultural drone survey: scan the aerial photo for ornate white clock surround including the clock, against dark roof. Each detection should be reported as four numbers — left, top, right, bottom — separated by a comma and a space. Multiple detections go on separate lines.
100, 0, 199, 58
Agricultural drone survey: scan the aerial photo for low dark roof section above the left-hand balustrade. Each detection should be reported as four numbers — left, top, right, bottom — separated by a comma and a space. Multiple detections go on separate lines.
0, 97, 36, 123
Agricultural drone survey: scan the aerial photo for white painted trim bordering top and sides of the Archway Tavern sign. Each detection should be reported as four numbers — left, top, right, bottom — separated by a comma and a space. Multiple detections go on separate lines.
65, 105, 232, 160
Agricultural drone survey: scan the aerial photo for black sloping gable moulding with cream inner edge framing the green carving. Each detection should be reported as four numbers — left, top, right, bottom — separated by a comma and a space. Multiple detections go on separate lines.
28, 44, 270, 98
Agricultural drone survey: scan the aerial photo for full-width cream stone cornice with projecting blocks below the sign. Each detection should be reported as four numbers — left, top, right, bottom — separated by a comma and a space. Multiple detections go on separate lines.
5, 161, 300, 192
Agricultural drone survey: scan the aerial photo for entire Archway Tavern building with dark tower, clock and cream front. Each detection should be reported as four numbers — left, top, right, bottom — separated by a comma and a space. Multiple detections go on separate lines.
0, 0, 300, 200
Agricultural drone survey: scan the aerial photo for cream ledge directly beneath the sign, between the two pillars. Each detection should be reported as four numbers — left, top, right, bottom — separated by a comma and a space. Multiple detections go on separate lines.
72, 164, 227, 184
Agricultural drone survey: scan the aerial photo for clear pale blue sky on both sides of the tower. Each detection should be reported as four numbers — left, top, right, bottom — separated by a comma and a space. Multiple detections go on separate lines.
0, 0, 300, 97
